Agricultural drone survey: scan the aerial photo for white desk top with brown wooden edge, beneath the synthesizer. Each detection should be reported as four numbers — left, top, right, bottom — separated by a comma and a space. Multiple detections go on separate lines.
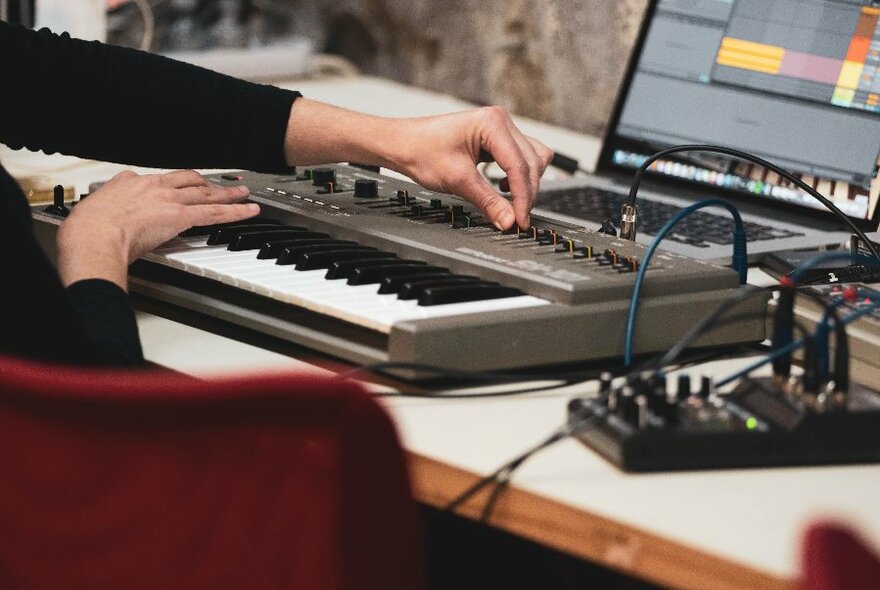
6, 78, 880, 588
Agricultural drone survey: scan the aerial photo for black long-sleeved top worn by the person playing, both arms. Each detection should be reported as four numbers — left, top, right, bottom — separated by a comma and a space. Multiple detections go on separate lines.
0, 22, 299, 365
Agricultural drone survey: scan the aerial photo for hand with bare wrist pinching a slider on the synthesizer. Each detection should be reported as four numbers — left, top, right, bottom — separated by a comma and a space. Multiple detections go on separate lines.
285, 98, 553, 229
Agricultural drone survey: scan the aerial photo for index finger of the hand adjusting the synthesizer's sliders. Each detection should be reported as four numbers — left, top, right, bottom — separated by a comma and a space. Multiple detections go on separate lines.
481, 107, 535, 227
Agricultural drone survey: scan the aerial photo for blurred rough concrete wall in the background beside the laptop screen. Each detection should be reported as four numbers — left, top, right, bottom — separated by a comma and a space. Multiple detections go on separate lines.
290, 0, 645, 134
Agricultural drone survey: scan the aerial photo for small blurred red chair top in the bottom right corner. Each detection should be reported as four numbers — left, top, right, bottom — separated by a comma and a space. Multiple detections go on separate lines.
800, 522, 880, 590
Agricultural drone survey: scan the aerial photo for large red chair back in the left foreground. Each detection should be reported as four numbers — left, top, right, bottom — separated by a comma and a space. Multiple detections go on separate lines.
0, 358, 423, 590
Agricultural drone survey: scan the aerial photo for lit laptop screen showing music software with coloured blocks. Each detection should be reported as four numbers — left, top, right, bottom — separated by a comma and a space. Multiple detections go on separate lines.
599, 0, 880, 225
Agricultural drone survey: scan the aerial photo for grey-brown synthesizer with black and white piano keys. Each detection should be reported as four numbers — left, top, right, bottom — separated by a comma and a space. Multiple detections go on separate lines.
33, 164, 767, 370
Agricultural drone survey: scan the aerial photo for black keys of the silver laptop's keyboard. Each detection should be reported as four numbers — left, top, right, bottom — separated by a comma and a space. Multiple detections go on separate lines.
538, 186, 804, 248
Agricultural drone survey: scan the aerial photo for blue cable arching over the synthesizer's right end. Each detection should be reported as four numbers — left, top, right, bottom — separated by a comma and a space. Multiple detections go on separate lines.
623, 199, 749, 367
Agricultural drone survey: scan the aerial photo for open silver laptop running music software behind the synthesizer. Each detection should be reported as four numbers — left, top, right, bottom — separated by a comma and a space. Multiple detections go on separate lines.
535, 0, 880, 262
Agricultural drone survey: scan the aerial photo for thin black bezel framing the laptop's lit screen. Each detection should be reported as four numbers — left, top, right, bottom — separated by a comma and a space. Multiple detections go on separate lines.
596, 0, 880, 230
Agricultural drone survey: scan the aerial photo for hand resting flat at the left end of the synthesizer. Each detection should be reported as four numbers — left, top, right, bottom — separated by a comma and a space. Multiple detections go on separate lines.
57, 170, 260, 289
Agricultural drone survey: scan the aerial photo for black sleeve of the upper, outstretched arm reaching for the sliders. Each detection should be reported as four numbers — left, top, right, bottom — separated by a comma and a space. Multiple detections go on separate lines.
0, 22, 299, 172
